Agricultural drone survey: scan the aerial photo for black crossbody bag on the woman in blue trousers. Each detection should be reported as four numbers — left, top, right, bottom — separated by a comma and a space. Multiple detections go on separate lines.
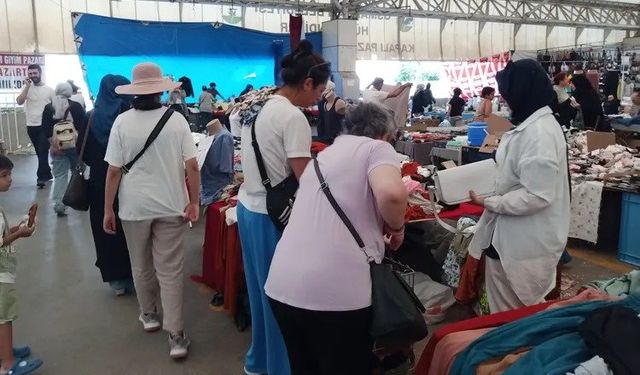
251, 117, 299, 231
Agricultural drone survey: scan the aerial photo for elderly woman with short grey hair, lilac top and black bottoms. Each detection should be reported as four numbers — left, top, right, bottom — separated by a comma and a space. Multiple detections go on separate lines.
265, 103, 407, 375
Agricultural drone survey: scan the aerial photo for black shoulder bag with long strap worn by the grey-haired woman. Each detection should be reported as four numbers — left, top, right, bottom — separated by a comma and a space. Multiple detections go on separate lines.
313, 158, 429, 346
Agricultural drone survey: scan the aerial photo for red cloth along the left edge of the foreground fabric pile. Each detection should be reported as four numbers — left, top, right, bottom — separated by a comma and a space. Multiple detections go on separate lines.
414, 301, 554, 375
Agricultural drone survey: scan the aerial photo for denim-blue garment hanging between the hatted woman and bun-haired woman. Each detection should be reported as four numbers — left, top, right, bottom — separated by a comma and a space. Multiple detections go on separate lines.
200, 128, 233, 205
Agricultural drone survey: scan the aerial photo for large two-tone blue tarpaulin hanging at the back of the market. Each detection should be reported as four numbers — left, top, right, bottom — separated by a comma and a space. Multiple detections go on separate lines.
74, 14, 322, 97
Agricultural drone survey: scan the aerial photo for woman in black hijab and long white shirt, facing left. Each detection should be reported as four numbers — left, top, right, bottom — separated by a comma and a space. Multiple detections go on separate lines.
469, 59, 570, 313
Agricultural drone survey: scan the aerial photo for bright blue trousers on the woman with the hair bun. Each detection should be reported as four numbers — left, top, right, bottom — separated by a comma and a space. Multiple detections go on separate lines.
238, 203, 291, 375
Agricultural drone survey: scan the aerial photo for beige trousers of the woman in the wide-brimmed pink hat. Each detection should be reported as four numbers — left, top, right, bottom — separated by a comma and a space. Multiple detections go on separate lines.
122, 217, 187, 333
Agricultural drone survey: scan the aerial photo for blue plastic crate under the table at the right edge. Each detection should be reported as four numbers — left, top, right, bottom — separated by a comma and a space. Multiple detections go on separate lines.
618, 193, 640, 266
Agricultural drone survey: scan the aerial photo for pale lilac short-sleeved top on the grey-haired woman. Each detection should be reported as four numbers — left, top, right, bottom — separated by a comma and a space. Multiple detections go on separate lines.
264, 135, 400, 311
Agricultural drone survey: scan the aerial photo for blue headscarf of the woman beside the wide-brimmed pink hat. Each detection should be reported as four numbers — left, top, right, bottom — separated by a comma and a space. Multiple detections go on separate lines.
91, 74, 133, 146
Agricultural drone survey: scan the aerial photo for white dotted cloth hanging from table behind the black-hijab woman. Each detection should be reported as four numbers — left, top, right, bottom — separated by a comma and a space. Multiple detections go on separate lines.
569, 181, 604, 243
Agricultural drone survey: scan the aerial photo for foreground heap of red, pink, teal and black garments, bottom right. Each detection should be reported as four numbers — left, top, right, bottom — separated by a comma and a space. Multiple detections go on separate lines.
415, 289, 640, 375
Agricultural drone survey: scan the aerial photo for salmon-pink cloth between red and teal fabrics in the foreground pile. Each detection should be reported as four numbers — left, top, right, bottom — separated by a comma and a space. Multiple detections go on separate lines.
427, 328, 493, 375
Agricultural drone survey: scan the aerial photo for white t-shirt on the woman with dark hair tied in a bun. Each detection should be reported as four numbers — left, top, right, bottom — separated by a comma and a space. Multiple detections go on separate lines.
238, 95, 311, 215
